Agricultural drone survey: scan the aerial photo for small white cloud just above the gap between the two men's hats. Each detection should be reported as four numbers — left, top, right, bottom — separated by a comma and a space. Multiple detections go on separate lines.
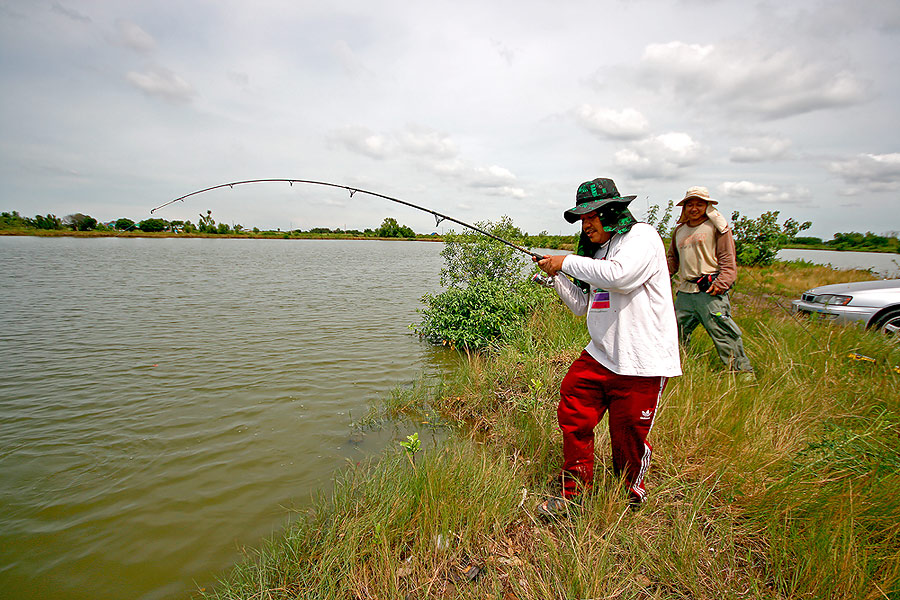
614, 132, 703, 179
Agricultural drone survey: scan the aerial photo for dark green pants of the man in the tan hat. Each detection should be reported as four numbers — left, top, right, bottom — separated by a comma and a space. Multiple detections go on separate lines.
675, 292, 753, 371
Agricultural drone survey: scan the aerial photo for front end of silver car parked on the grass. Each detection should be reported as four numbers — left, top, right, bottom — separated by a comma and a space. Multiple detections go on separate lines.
791, 279, 900, 336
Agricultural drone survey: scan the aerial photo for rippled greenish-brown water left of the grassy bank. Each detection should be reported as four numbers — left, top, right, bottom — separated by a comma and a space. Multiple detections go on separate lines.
0, 237, 448, 599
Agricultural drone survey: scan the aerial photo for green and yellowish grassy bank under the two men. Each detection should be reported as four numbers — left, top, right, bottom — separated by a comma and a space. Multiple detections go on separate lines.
205, 265, 900, 600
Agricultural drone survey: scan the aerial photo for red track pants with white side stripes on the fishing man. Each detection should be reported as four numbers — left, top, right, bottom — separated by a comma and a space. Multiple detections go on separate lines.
556, 351, 666, 502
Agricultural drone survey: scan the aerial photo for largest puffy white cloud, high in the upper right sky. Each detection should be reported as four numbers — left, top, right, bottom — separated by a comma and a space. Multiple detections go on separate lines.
640, 41, 868, 119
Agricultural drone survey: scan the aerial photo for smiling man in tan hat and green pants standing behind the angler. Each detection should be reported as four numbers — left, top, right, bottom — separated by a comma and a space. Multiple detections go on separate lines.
667, 186, 755, 379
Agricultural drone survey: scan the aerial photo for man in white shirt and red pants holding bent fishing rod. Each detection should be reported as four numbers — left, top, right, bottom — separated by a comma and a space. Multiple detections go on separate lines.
534, 178, 681, 517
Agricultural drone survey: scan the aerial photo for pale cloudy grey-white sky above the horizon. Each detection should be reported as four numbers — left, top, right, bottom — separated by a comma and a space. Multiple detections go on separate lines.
0, 0, 900, 239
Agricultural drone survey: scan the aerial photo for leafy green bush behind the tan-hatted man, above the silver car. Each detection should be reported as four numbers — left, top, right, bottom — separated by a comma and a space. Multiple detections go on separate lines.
731, 210, 812, 265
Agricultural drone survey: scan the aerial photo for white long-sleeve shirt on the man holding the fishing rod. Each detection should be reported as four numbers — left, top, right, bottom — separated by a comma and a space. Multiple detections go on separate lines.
553, 223, 681, 377
